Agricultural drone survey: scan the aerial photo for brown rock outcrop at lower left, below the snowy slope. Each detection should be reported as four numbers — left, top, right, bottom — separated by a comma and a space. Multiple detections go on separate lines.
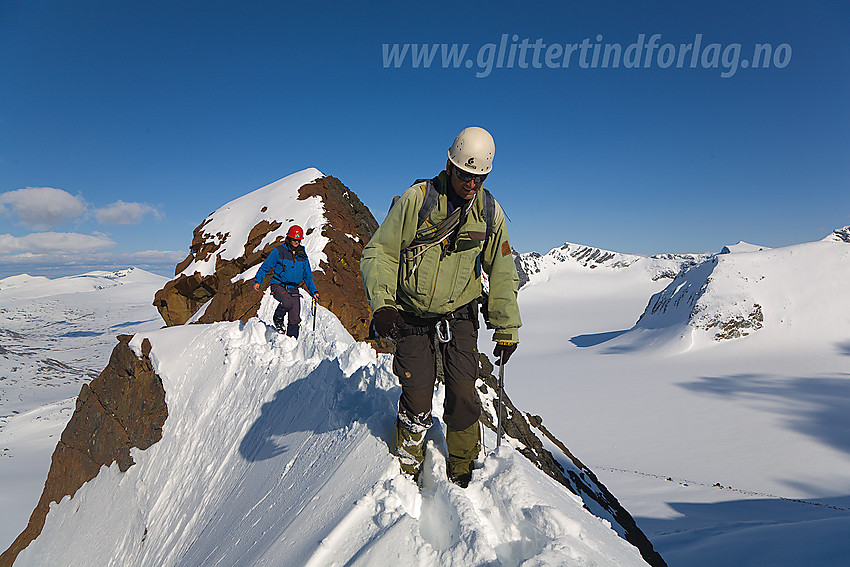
0, 335, 168, 567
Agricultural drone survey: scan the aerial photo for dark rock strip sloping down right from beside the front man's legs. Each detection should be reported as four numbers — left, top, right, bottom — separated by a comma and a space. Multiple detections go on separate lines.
478, 353, 667, 567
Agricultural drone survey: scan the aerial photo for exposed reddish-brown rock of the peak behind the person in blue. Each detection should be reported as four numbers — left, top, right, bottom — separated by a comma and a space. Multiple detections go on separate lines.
154, 177, 378, 340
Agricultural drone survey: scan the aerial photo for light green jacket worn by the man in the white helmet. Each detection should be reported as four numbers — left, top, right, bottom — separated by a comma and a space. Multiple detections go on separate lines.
360, 171, 522, 341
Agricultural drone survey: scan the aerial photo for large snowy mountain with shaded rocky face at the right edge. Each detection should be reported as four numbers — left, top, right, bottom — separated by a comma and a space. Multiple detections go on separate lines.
618, 239, 850, 350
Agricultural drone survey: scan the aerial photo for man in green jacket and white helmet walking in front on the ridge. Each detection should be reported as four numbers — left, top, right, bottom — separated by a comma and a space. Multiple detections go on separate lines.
360, 126, 522, 487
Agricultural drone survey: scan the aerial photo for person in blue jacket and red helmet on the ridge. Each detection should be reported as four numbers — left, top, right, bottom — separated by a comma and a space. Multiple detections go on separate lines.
254, 224, 319, 339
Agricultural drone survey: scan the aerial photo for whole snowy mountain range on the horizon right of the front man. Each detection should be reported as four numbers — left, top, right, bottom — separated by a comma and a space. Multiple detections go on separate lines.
515, 226, 850, 356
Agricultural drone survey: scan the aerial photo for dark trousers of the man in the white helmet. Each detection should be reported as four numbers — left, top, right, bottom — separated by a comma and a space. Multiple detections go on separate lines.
393, 308, 481, 431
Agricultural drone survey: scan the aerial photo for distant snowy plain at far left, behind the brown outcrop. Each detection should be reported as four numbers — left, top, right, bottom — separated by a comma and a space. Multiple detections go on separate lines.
0, 268, 168, 549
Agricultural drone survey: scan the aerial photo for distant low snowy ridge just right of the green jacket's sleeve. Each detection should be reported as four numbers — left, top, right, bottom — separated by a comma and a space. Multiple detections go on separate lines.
515, 242, 710, 287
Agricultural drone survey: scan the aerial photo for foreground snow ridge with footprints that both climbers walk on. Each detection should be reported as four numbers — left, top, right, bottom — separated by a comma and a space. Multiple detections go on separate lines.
16, 296, 644, 567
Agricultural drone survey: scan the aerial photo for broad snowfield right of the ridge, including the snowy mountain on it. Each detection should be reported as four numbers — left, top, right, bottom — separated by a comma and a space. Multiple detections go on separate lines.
506, 234, 850, 567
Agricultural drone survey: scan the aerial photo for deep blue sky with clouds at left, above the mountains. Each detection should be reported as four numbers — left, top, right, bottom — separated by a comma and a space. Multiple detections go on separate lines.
0, 1, 850, 277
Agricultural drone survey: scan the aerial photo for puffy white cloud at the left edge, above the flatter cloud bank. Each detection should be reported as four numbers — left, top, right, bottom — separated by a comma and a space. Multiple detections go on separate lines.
0, 187, 86, 227
